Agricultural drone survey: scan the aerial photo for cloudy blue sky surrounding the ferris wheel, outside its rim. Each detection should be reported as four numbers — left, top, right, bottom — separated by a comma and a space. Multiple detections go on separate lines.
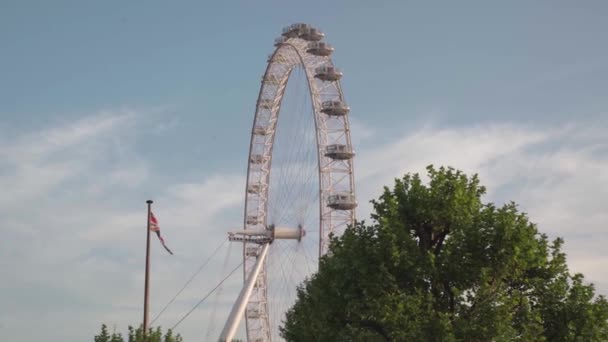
0, 0, 608, 341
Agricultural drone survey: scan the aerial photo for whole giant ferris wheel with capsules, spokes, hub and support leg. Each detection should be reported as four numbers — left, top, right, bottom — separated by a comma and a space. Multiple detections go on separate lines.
220, 23, 357, 342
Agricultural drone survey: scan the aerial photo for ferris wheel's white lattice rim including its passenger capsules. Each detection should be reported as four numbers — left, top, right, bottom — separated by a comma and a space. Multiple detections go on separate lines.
223, 24, 357, 342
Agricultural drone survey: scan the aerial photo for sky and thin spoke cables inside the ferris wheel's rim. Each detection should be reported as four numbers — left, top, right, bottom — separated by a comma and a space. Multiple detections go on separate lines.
267, 68, 319, 339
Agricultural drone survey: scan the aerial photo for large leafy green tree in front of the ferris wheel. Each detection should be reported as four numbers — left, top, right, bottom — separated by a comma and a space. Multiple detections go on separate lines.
281, 166, 608, 342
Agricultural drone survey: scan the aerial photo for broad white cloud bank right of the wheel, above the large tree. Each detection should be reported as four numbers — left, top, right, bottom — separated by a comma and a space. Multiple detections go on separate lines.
356, 120, 608, 294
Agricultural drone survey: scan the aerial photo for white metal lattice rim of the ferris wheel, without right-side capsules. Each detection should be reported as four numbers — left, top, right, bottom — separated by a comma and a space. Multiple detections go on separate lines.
235, 24, 355, 342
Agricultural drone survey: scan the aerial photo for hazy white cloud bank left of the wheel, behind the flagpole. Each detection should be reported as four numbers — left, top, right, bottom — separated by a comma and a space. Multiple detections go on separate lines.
0, 110, 244, 340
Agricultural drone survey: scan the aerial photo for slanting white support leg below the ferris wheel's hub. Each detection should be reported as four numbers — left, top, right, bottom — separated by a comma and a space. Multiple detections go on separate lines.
219, 243, 270, 342
